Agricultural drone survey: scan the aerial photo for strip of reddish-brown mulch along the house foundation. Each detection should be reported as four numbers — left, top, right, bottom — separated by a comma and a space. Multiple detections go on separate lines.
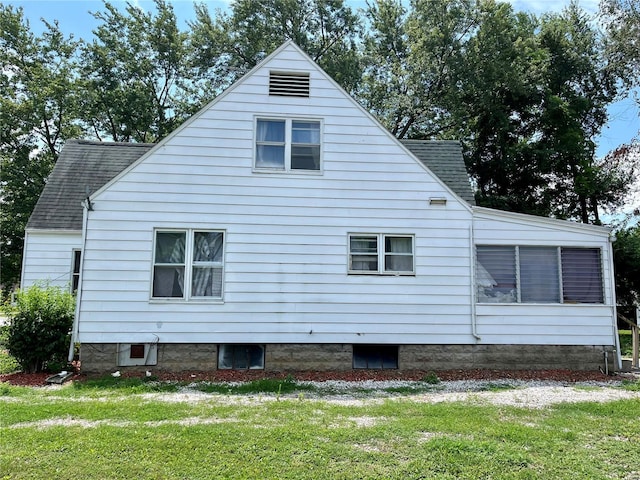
0, 370, 624, 386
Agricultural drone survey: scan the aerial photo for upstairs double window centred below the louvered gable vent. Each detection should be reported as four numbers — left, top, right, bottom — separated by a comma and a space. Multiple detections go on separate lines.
255, 118, 321, 171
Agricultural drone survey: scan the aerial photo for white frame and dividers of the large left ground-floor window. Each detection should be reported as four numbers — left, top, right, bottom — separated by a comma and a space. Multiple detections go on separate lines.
149, 228, 227, 303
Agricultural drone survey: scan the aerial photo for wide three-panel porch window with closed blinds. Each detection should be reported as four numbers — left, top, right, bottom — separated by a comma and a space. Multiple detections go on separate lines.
476, 245, 604, 303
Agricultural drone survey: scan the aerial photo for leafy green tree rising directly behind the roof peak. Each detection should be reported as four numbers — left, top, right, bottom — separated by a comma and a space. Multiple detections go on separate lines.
190, 0, 361, 101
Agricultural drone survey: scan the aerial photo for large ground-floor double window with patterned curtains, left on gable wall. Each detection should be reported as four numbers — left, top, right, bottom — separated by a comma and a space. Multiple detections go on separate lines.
151, 230, 224, 300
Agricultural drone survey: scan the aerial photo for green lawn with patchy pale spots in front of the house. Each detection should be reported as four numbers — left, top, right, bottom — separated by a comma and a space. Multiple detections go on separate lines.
0, 379, 640, 480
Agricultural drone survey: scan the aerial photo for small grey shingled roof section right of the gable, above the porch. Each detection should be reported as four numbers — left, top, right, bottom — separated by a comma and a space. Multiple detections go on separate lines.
401, 140, 476, 205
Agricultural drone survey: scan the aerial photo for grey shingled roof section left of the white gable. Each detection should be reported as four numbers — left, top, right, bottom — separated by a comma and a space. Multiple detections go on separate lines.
27, 140, 153, 231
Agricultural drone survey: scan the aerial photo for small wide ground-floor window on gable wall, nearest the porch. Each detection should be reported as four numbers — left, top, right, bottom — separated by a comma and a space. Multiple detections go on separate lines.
349, 233, 415, 275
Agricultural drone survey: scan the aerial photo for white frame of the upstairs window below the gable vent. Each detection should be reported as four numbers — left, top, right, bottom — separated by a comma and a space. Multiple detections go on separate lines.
253, 116, 324, 175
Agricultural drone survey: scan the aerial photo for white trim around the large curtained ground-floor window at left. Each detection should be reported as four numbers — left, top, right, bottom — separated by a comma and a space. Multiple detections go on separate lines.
149, 228, 227, 304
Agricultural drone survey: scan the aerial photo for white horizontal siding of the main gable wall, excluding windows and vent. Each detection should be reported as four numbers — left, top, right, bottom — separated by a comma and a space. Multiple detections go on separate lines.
79, 43, 472, 345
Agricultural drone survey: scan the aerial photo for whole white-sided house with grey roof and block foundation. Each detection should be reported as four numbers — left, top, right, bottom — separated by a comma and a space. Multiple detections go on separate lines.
22, 42, 619, 372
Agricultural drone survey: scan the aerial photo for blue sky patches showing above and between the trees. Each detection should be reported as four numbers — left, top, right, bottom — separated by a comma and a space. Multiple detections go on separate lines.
6, 0, 640, 156
